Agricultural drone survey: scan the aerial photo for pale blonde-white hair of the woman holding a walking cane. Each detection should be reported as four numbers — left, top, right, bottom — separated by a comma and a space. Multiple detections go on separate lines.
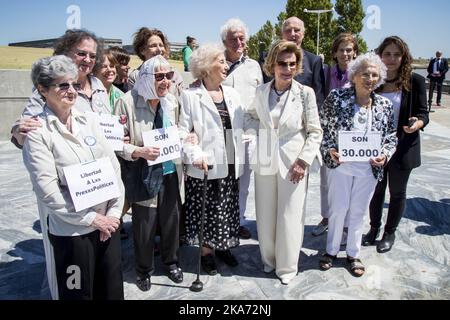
189, 43, 225, 80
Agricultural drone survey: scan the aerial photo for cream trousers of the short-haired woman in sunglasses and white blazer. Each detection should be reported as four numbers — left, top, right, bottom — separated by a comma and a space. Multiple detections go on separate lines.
255, 173, 308, 282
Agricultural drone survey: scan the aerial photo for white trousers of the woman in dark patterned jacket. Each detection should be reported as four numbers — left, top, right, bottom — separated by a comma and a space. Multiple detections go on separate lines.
327, 169, 377, 258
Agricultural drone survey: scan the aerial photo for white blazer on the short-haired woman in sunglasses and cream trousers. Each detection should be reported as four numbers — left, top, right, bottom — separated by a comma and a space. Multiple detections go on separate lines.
246, 80, 322, 179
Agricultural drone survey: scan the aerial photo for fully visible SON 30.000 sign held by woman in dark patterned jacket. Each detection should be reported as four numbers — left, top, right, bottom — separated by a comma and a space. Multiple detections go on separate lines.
338, 131, 381, 162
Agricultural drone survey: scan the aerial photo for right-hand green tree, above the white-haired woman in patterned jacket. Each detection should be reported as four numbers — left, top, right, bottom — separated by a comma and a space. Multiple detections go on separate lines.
334, 0, 367, 53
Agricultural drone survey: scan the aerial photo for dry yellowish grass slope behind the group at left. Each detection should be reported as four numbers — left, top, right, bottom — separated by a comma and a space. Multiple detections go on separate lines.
0, 46, 183, 71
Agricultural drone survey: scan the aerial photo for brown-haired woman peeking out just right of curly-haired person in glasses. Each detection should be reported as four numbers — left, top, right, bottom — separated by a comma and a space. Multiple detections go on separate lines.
93, 49, 123, 114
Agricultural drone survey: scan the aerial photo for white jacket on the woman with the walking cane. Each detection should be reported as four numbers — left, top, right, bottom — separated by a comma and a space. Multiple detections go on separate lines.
178, 84, 245, 180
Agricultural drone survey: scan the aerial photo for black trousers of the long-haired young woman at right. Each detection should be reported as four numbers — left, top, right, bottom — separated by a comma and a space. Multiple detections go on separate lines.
369, 163, 412, 233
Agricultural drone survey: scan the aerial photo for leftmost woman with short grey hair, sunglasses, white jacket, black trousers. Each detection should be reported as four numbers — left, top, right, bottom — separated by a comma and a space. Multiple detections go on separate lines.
23, 55, 123, 300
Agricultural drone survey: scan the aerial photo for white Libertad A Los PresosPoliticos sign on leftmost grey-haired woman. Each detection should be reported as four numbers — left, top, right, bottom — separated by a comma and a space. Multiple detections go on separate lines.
63, 158, 120, 212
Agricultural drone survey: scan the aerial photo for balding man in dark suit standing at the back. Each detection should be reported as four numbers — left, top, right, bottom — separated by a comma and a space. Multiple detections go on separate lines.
281, 17, 325, 109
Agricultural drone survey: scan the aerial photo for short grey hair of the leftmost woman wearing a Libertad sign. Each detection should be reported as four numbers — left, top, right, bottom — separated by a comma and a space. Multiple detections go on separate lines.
31, 55, 78, 88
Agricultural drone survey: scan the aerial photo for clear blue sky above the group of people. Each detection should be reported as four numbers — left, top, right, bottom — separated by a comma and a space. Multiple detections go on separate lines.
0, 0, 450, 58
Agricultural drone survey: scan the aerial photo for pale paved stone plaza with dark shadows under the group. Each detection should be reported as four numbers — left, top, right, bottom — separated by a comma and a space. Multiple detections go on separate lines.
0, 96, 450, 300
